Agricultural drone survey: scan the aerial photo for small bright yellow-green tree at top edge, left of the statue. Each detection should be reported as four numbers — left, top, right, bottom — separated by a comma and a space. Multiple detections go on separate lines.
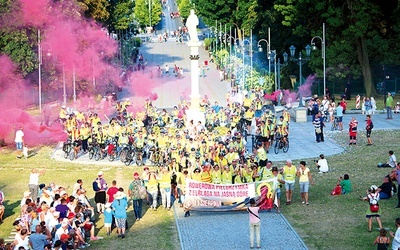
134, 0, 162, 27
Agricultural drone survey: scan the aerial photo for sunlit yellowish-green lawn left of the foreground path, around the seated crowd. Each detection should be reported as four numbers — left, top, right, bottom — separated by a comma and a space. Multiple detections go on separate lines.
0, 147, 180, 250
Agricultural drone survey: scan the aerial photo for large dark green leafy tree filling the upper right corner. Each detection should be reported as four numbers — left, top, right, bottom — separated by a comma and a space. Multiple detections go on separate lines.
274, 0, 400, 96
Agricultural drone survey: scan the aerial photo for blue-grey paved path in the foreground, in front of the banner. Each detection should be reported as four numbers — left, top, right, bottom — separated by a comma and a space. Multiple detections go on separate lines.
174, 206, 307, 250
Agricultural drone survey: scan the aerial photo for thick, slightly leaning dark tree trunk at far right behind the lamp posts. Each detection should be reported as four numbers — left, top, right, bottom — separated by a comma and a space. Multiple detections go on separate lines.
356, 37, 376, 97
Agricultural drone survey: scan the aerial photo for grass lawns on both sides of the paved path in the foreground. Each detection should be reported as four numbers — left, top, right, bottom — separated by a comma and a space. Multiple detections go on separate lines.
0, 130, 400, 249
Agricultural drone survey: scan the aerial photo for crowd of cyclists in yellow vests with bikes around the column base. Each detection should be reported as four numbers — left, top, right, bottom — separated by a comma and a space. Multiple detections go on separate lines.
60, 87, 290, 173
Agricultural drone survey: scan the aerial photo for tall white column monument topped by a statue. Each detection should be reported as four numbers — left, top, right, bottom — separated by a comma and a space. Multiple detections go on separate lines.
186, 10, 205, 126
